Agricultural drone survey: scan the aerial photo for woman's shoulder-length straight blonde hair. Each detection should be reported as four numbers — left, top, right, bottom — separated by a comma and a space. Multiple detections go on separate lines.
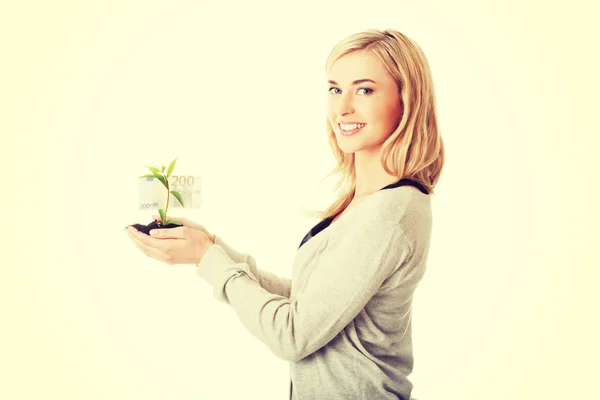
304, 29, 444, 219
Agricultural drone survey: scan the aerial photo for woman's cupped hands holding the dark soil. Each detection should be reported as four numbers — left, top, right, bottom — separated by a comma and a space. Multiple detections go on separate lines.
125, 223, 214, 265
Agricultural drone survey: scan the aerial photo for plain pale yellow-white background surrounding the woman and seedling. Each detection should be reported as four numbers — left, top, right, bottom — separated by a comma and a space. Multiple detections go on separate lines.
0, 0, 600, 400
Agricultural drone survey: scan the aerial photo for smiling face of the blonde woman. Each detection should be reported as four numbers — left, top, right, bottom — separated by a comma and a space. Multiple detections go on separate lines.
327, 50, 402, 155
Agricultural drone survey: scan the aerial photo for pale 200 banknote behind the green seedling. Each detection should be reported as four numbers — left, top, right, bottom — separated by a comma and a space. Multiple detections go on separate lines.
138, 175, 202, 214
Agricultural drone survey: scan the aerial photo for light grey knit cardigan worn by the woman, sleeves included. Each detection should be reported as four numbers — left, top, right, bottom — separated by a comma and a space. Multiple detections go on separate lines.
197, 179, 432, 400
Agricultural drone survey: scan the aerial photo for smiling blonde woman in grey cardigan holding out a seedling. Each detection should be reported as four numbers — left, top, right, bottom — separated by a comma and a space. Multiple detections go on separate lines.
128, 30, 444, 400
